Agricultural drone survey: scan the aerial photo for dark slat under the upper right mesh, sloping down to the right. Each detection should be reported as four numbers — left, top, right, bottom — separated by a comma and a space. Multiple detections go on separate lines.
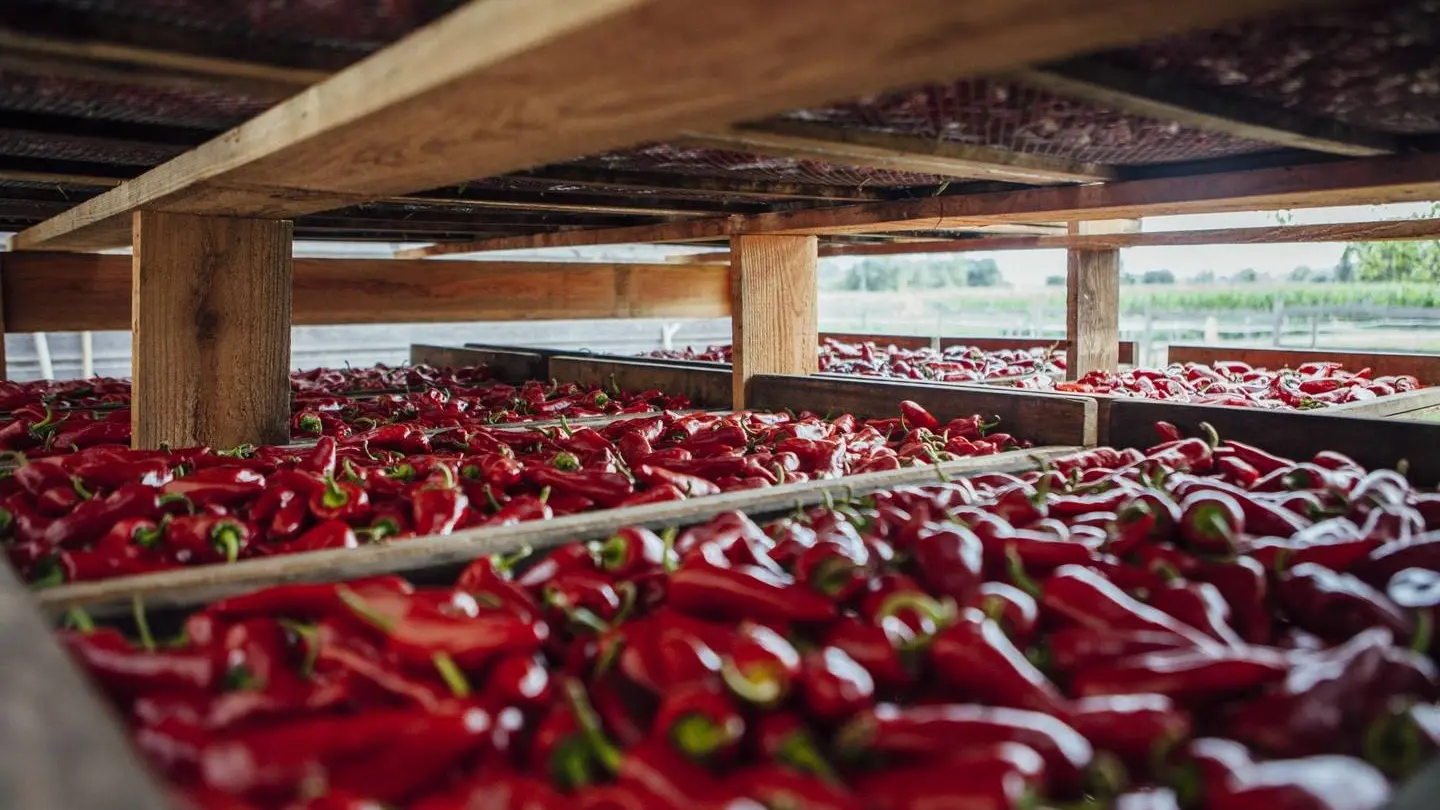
1008, 59, 1403, 157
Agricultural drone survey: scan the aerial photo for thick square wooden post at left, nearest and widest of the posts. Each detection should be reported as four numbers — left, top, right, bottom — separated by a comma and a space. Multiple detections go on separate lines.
131, 210, 292, 447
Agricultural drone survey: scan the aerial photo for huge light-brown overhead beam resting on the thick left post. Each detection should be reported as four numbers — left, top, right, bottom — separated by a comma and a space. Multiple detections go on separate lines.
14, 0, 1315, 249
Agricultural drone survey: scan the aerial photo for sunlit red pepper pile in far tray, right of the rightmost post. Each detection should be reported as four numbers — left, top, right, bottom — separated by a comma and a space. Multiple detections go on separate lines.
1020, 362, 1424, 409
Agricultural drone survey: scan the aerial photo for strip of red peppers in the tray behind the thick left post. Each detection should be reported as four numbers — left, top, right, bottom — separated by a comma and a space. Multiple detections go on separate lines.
0, 369, 690, 457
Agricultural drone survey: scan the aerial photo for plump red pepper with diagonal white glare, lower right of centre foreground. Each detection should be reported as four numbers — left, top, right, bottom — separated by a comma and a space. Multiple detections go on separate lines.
930, 610, 1061, 712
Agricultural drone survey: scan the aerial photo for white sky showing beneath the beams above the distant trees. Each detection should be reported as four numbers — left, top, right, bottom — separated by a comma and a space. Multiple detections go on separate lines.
827, 203, 1431, 287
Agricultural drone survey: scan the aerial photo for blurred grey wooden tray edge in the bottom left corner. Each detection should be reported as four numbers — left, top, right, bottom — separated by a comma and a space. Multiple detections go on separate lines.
0, 565, 170, 810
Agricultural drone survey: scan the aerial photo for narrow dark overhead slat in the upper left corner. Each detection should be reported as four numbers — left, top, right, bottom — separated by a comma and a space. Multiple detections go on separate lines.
0, 27, 321, 101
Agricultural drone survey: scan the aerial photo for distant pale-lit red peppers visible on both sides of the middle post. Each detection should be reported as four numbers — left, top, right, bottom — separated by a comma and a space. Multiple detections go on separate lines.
647, 337, 1066, 382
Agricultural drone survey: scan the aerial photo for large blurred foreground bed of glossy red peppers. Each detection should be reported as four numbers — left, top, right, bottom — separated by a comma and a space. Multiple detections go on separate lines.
63, 425, 1440, 810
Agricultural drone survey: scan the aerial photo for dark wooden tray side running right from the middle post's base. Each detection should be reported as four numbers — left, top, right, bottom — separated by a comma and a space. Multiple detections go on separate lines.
746, 375, 1097, 444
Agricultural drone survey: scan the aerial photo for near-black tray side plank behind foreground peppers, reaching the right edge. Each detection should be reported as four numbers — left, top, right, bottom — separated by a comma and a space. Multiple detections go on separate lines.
1109, 399, 1440, 486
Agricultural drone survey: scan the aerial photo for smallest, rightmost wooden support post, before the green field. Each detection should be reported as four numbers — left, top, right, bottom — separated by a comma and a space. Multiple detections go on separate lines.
1066, 219, 1140, 379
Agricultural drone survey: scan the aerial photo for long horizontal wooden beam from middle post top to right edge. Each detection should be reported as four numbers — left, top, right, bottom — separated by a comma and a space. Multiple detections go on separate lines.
737, 154, 1440, 233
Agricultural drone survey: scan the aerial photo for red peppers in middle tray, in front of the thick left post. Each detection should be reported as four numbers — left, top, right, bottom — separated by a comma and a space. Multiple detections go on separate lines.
0, 402, 1028, 587
